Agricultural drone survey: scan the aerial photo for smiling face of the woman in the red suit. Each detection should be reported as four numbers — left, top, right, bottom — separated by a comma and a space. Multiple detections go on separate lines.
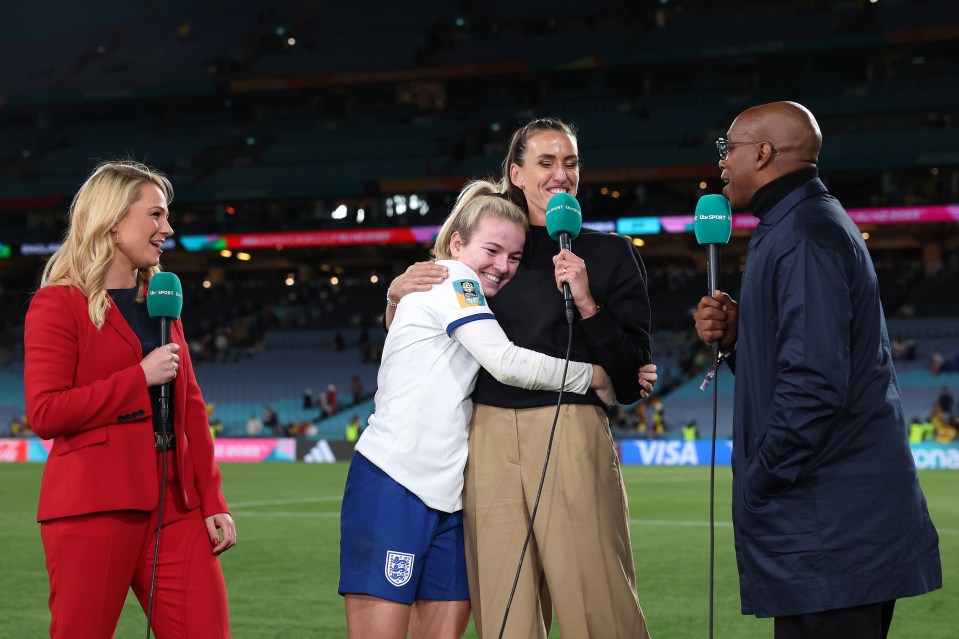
107, 183, 173, 288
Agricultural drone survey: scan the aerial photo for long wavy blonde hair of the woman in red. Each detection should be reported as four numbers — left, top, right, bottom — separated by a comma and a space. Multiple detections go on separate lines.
40, 160, 173, 328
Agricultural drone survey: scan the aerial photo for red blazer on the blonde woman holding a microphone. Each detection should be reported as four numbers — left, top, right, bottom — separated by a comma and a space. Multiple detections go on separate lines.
23, 286, 228, 521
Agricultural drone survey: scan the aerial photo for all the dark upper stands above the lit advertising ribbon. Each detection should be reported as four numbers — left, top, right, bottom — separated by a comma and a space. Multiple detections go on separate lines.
0, 0, 959, 222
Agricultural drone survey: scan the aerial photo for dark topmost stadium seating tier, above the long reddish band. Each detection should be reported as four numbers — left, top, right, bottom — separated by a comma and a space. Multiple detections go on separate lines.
0, 0, 959, 93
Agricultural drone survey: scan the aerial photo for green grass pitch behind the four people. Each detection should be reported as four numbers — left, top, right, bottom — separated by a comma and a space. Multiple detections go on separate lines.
0, 462, 959, 639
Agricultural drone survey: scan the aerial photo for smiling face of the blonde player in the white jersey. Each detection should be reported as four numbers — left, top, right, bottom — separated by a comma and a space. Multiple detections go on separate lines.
450, 214, 526, 297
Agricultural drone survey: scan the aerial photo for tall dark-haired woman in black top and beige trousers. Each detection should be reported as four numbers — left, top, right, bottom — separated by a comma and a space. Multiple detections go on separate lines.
387, 118, 656, 639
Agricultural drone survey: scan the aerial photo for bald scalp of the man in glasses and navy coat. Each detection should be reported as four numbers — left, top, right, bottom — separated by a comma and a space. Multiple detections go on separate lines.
730, 102, 822, 171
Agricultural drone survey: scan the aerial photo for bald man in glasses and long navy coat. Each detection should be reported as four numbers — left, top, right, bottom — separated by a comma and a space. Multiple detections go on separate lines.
694, 102, 942, 639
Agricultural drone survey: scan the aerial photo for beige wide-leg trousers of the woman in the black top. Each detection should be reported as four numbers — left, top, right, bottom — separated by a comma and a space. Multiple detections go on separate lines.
463, 405, 649, 639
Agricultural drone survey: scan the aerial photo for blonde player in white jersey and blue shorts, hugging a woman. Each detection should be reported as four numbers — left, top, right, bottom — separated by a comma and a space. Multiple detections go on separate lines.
339, 181, 615, 639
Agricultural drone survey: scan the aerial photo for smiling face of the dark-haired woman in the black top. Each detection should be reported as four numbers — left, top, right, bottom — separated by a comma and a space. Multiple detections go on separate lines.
509, 130, 579, 226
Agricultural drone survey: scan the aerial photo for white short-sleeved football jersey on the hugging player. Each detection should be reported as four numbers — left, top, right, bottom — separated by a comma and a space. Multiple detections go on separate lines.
356, 260, 496, 512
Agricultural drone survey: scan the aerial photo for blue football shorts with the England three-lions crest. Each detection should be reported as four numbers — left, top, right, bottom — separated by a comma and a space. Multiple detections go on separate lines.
339, 453, 469, 604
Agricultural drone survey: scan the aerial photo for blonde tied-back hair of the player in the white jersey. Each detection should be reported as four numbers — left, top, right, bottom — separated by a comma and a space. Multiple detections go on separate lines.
431, 180, 529, 260
